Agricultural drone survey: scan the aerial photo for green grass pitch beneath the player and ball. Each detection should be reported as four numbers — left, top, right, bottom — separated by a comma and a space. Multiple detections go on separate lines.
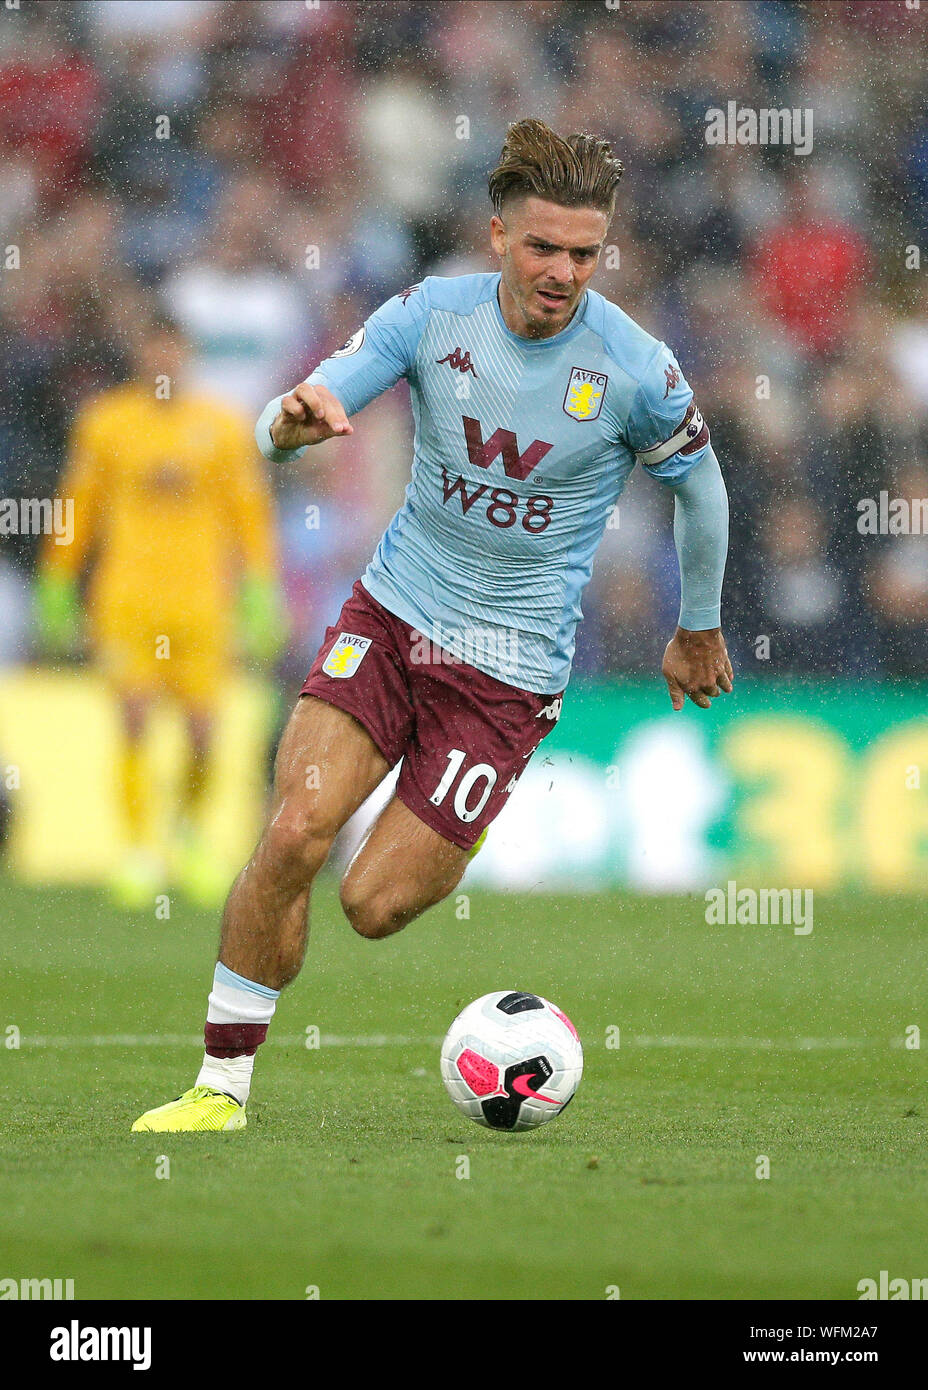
0, 880, 928, 1300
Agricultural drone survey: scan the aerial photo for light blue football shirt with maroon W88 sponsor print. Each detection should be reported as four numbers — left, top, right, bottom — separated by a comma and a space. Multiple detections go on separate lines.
256, 274, 721, 695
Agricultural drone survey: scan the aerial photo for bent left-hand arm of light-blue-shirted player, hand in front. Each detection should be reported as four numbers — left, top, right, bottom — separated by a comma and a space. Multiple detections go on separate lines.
254, 286, 428, 463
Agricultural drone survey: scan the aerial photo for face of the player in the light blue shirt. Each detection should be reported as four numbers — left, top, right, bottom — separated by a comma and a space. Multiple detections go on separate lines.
490, 196, 608, 338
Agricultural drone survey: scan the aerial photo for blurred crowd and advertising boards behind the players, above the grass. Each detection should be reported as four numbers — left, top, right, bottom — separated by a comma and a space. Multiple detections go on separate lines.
0, 0, 928, 888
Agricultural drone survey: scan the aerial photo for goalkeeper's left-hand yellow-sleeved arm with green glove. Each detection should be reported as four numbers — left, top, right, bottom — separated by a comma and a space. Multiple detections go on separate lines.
35, 406, 103, 652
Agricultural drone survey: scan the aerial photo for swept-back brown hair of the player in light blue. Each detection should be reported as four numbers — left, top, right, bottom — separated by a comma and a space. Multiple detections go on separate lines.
489, 117, 624, 217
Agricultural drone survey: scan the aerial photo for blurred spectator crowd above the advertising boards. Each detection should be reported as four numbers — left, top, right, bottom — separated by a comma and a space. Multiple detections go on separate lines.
0, 0, 928, 680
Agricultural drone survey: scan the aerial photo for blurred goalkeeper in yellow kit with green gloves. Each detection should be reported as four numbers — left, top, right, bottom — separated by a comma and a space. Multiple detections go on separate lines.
36, 320, 286, 906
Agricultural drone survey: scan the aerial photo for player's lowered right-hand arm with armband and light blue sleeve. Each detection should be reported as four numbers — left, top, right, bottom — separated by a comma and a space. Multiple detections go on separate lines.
629, 343, 734, 709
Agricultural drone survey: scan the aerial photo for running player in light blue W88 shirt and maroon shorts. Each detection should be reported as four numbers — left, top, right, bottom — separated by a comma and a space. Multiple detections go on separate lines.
133, 120, 732, 1130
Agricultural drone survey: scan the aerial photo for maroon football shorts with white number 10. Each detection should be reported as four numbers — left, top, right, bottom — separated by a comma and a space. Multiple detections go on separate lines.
300, 580, 563, 849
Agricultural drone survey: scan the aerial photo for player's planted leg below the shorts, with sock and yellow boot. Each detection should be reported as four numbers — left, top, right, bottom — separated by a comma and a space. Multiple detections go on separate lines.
133, 696, 389, 1130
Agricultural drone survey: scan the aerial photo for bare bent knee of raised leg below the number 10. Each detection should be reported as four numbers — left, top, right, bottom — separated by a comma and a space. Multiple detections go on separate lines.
340, 796, 472, 940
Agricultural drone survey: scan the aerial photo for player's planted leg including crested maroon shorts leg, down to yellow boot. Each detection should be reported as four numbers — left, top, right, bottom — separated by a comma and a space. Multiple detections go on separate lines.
135, 581, 415, 1129
